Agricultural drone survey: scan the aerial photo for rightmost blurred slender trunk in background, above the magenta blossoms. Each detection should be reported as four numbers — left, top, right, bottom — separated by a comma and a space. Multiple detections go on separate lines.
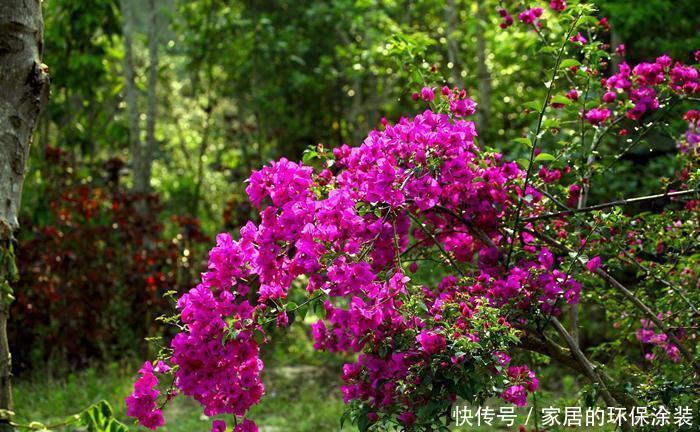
476, 0, 491, 137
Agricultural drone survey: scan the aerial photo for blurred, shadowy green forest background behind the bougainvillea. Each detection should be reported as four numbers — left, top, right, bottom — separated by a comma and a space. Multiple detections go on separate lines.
9, 0, 700, 431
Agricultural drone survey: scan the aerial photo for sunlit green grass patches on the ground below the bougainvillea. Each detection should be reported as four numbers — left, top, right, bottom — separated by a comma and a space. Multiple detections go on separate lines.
14, 364, 350, 432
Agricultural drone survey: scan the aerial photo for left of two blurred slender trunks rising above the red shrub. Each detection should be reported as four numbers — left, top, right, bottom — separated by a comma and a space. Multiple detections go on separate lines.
120, 0, 145, 192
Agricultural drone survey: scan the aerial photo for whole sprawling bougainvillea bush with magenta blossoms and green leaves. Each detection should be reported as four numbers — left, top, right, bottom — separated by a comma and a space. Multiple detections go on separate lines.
126, 1, 700, 432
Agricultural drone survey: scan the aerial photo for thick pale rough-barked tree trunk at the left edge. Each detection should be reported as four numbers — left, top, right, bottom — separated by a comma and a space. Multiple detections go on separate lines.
0, 0, 49, 424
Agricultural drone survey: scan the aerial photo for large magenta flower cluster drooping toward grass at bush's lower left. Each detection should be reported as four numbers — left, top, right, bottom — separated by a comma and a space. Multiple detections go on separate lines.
171, 280, 264, 416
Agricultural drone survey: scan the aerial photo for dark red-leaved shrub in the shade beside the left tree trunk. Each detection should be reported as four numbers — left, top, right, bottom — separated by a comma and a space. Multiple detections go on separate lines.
9, 148, 208, 370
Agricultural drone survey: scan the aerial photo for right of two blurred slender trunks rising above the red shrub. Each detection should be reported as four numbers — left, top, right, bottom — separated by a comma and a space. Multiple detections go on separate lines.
145, 0, 160, 192
